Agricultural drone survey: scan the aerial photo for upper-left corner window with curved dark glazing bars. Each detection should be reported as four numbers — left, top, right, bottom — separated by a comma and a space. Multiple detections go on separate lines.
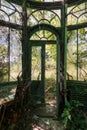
0, 0, 22, 25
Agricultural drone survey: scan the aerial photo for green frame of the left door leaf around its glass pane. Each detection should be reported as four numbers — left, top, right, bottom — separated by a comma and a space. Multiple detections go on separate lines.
28, 40, 45, 102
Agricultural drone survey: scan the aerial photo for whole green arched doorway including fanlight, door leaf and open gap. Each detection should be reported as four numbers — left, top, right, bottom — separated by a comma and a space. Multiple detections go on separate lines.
28, 24, 61, 114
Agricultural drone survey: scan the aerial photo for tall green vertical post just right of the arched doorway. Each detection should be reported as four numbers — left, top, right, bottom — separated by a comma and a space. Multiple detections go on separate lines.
61, 3, 67, 104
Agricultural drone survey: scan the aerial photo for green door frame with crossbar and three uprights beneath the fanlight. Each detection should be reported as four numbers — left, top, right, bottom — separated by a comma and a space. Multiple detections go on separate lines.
29, 40, 60, 108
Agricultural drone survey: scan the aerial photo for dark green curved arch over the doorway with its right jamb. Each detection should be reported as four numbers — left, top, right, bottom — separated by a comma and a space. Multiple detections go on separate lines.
28, 24, 61, 115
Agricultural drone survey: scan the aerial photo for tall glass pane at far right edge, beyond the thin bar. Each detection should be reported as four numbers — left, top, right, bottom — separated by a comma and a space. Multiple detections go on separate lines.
78, 28, 87, 81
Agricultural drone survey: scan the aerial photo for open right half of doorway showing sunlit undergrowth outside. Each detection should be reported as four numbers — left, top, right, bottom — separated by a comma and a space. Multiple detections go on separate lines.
45, 44, 57, 115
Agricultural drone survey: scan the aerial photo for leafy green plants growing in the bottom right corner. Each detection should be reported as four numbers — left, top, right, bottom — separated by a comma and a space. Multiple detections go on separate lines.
62, 100, 87, 130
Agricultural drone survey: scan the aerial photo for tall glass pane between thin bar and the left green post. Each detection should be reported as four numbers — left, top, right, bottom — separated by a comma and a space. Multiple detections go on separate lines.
10, 29, 22, 81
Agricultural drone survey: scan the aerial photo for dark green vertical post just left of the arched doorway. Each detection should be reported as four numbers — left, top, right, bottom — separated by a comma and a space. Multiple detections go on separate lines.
22, 0, 28, 80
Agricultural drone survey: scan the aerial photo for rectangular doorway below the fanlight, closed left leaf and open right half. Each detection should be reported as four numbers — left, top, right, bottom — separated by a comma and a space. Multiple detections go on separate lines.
29, 40, 58, 114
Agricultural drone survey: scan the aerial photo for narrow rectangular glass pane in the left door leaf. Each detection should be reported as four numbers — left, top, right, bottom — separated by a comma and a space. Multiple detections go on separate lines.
31, 46, 41, 80
